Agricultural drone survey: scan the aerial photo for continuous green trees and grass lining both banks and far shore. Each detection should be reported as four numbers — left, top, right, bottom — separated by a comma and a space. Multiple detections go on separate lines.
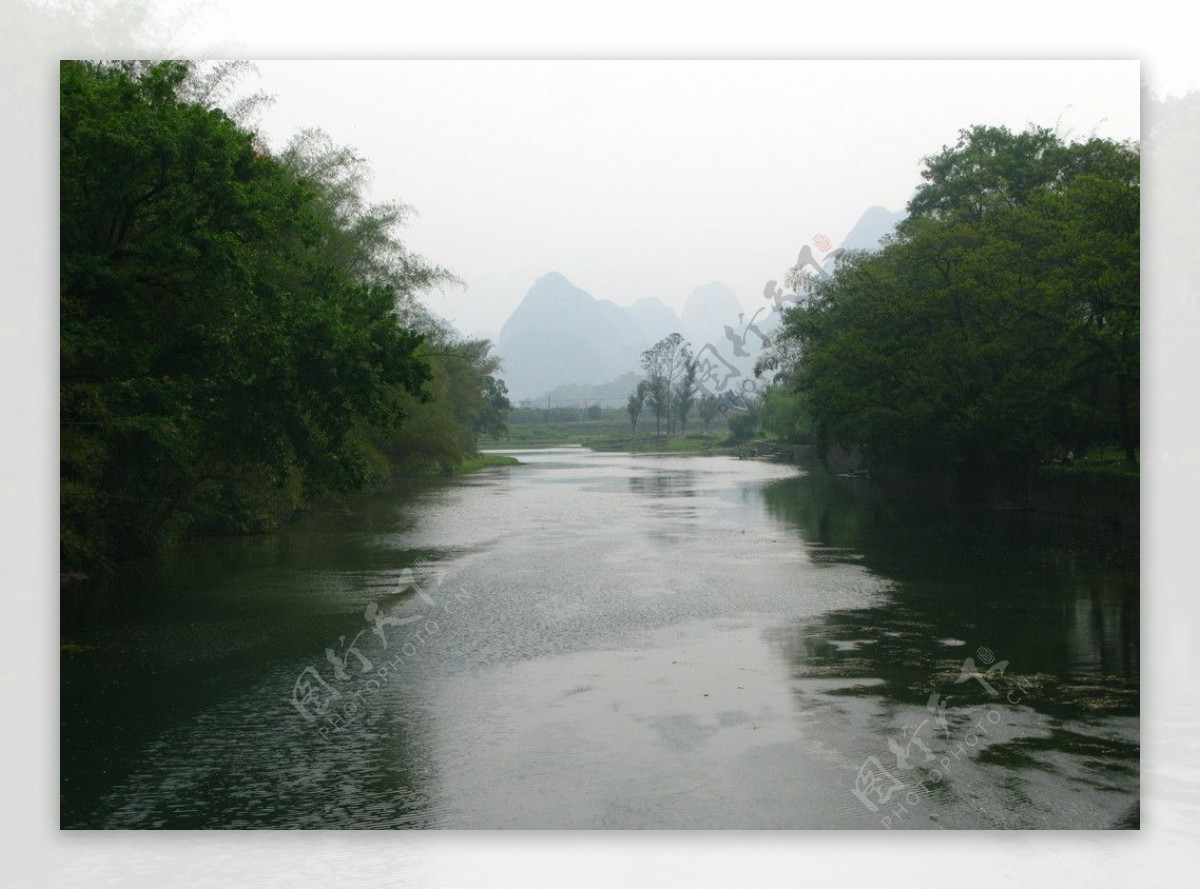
60, 61, 1140, 572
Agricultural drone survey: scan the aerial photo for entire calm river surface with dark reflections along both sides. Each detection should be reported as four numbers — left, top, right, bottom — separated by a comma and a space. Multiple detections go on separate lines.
60, 449, 1140, 829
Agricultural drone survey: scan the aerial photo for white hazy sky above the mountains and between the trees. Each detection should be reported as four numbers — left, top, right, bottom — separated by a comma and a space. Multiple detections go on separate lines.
244, 60, 1140, 336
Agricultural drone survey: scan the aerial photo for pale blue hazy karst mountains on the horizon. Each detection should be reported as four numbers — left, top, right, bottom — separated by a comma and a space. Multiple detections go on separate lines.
496, 208, 905, 402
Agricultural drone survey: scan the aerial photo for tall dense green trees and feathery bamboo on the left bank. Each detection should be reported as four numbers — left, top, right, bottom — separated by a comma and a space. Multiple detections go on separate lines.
60, 61, 509, 570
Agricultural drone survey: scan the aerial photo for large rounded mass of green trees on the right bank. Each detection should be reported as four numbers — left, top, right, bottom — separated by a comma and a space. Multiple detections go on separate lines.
756, 126, 1140, 479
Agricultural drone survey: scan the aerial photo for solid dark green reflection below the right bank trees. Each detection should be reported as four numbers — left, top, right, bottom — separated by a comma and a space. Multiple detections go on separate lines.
763, 470, 1139, 712
